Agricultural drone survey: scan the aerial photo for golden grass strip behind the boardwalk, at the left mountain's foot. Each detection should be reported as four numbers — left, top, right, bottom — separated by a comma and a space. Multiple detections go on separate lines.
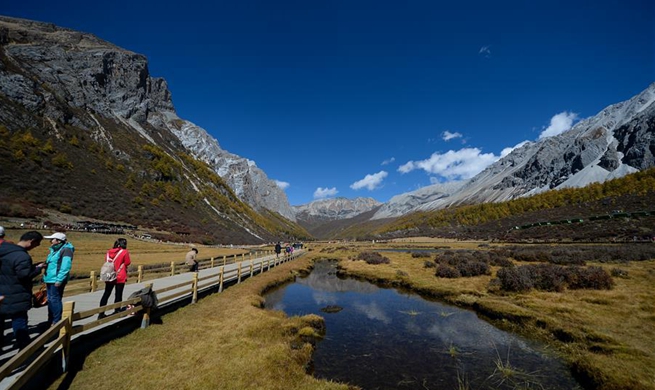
7, 230, 247, 275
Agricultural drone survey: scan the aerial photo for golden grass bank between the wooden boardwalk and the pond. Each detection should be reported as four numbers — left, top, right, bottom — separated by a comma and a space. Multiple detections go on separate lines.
50, 254, 350, 390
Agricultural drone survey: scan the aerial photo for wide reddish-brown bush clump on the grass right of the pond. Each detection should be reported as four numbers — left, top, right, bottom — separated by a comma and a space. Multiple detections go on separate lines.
497, 264, 614, 292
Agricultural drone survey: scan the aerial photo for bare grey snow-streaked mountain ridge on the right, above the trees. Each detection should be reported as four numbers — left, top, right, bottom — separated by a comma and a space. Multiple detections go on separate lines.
372, 83, 655, 219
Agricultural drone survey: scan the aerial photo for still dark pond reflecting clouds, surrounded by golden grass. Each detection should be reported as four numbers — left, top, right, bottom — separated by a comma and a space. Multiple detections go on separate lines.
266, 261, 580, 390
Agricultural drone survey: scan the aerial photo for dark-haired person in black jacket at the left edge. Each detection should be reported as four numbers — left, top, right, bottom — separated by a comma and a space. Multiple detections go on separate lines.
0, 231, 43, 349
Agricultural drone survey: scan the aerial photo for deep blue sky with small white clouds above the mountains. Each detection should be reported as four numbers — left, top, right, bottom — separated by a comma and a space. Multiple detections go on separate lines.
0, 0, 655, 205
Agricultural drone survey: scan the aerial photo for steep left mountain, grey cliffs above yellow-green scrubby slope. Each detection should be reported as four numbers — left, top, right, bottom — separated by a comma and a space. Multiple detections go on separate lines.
0, 17, 308, 243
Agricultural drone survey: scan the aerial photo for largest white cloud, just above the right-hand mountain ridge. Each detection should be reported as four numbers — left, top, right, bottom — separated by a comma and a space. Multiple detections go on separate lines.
398, 148, 499, 180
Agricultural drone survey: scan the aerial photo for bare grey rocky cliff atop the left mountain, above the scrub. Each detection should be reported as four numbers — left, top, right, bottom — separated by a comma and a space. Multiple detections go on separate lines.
0, 17, 294, 219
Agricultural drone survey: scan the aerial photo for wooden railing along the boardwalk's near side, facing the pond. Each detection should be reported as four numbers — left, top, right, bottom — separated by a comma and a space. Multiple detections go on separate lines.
0, 251, 303, 390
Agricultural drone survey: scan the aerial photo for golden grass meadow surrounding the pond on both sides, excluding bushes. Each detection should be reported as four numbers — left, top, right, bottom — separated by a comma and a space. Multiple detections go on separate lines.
43, 240, 655, 390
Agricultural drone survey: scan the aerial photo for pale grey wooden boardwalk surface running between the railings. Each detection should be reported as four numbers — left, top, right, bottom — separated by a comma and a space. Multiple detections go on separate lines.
0, 251, 303, 390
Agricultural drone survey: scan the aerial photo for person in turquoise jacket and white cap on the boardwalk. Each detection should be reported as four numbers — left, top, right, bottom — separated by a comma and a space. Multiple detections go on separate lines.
43, 232, 75, 325
